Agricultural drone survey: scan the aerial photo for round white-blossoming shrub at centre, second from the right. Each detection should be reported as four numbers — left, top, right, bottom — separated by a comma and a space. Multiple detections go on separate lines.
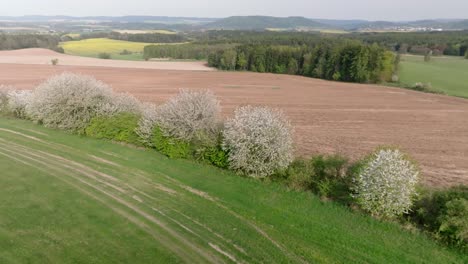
223, 106, 293, 178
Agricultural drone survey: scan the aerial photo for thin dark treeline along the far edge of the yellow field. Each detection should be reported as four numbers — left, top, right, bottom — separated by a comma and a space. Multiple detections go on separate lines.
74, 31, 187, 43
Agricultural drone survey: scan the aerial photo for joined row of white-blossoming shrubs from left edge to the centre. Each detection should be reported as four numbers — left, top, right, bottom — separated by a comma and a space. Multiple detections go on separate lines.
0, 73, 293, 178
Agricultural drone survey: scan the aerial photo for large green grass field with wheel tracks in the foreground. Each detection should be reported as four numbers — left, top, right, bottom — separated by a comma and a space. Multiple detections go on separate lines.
0, 118, 468, 263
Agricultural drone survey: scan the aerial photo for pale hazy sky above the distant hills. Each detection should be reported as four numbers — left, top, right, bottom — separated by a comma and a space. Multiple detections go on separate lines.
0, 0, 468, 20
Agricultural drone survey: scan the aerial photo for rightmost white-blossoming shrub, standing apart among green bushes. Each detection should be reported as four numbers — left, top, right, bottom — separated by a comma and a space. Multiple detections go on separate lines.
353, 149, 419, 218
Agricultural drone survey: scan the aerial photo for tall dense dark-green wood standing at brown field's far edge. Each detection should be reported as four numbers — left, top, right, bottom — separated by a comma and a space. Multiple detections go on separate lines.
208, 41, 398, 83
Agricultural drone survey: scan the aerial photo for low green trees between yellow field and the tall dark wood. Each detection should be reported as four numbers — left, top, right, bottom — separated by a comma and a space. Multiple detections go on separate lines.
143, 44, 235, 60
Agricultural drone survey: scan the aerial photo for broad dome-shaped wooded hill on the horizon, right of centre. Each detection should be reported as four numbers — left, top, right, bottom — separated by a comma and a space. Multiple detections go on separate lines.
204, 16, 330, 30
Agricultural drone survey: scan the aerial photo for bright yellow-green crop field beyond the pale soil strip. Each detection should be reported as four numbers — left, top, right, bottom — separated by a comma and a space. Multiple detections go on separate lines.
60, 38, 186, 60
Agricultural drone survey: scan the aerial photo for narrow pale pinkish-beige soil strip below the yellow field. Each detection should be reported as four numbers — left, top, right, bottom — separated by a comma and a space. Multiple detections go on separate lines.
0, 49, 215, 71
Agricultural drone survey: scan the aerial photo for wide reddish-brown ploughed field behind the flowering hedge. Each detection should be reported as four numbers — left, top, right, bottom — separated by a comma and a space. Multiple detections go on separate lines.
0, 55, 468, 186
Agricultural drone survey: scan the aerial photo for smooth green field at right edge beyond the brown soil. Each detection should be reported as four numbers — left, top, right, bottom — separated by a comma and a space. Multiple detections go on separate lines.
400, 55, 468, 98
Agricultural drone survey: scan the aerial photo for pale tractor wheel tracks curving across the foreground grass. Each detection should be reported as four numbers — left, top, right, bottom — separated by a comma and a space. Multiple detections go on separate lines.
0, 129, 304, 263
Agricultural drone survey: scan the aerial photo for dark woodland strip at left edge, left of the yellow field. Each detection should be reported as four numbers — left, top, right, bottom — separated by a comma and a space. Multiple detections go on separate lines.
0, 34, 63, 53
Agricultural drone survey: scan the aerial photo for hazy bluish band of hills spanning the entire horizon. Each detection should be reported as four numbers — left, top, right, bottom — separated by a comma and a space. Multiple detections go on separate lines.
0, 15, 468, 31
